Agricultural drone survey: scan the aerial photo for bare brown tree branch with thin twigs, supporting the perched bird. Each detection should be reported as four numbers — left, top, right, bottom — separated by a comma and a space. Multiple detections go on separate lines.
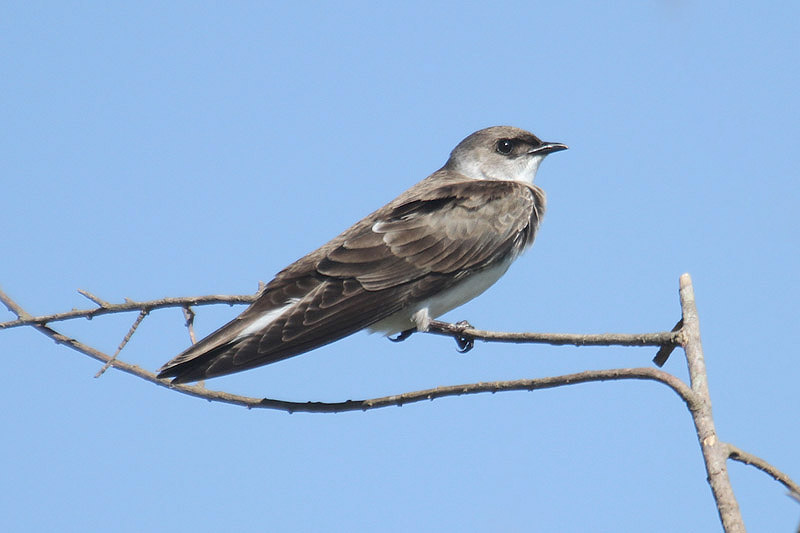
0, 274, 800, 533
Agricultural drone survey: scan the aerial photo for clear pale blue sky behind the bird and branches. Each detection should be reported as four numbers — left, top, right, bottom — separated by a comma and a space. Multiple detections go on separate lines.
0, 1, 800, 532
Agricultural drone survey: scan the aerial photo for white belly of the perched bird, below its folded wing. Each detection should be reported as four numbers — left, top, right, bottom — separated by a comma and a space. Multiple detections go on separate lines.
369, 258, 513, 335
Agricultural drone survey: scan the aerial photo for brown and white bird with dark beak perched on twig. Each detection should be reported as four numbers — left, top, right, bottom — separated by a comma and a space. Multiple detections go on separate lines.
158, 126, 567, 384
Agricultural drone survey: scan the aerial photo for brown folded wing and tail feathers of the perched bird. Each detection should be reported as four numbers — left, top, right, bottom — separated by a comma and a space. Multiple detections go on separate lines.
159, 180, 544, 382
